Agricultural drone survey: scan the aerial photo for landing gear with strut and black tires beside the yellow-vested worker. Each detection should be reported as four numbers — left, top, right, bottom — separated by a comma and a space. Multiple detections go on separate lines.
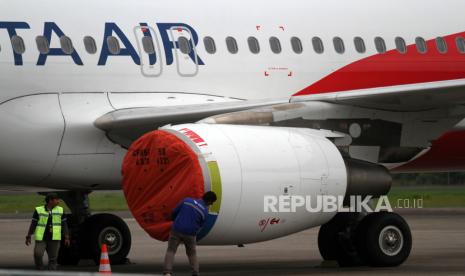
58, 191, 131, 265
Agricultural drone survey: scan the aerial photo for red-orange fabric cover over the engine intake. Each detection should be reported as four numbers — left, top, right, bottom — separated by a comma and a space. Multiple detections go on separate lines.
122, 130, 204, 241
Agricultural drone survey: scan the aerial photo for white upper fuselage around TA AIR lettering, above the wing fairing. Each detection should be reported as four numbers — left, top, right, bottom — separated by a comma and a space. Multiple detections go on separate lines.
0, 0, 465, 103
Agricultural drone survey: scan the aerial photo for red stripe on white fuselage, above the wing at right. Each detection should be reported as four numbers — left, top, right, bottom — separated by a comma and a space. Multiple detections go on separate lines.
294, 33, 465, 96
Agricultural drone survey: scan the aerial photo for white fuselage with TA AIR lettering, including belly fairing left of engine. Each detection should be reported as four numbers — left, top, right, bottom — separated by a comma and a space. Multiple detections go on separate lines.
0, 0, 465, 189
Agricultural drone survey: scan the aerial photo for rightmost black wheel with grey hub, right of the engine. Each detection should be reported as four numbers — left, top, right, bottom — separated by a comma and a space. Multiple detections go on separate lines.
356, 212, 412, 267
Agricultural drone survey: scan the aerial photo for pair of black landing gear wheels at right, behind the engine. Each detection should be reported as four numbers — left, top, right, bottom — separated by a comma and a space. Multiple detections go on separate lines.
318, 212, 412, 267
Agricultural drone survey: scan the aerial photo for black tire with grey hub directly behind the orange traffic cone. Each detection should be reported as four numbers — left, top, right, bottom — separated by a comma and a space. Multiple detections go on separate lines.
81, 214, 131, 264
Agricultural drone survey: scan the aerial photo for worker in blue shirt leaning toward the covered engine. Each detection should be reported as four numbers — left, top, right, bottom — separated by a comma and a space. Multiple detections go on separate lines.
163, 192, 216, 276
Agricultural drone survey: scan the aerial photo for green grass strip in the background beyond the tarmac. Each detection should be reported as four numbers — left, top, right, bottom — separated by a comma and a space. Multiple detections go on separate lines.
0, 186, 465, 214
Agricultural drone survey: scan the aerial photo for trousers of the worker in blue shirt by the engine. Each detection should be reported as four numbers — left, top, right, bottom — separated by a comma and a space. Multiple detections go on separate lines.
163, 230, 199, 275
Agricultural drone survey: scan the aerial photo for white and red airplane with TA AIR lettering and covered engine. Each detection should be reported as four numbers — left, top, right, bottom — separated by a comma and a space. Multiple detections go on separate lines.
0, 0, 465, 266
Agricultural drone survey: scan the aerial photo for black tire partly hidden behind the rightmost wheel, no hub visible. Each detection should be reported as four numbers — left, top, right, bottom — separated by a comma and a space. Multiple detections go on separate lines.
318, 213, 363, 266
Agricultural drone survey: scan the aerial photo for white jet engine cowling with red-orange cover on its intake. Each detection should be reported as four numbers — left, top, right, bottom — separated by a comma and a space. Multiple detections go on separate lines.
122, 124, 386, 245
